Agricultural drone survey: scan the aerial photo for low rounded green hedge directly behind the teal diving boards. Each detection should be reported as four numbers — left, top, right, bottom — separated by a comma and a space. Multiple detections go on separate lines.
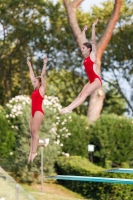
56, 156, 133, 200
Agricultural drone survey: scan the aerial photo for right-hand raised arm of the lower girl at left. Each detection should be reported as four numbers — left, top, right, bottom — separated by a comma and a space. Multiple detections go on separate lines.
40, 56, 48, 96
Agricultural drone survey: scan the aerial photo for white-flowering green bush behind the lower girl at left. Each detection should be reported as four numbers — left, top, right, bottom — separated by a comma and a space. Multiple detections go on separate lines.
5, 96, 60, 183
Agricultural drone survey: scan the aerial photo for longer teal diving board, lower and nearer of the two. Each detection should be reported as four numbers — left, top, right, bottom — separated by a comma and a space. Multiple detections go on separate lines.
46, 175, 133, 184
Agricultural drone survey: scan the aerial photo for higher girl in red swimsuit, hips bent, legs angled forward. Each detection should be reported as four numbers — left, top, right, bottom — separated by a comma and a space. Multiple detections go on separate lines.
60, 19, 102, 114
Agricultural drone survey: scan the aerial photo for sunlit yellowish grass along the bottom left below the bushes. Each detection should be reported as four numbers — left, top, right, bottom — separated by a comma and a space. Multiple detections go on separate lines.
0, 177, 88, 200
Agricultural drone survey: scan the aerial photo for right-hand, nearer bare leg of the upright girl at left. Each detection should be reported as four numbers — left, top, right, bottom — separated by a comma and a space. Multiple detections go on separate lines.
31, 111, 44, 161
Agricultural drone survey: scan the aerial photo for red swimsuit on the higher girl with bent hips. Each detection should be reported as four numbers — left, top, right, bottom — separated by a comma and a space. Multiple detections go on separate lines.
83, 56, 102, 85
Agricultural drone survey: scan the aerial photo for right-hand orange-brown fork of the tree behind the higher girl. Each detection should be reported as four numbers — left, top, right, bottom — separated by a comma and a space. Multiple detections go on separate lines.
97, 0, 122, 60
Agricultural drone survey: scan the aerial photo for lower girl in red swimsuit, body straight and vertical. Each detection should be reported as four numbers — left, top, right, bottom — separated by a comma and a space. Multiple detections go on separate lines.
27, 57, 48, 162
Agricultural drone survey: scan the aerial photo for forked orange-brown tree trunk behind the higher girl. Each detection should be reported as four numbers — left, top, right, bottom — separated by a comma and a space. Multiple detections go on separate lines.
64, 0, 122, 123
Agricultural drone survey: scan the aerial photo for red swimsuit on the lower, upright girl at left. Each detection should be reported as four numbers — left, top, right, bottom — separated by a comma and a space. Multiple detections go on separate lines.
31, 89, 44, 117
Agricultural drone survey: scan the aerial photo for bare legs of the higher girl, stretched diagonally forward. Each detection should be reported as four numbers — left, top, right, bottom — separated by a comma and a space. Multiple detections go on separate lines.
60, 79, 101, 114
